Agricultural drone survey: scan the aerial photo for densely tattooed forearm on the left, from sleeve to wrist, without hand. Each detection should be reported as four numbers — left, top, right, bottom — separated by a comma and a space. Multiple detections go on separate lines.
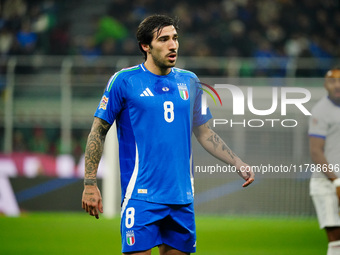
84, 118, 111, 186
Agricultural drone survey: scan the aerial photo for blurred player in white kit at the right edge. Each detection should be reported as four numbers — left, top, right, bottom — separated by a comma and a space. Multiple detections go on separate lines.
309, 68, 340, 255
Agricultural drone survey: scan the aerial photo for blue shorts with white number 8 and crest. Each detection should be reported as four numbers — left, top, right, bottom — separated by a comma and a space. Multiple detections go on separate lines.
120, 199, 196, 253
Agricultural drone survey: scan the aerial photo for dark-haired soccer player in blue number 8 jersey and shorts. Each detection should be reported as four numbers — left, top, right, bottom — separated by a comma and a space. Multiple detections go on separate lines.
82, 15, 254, 255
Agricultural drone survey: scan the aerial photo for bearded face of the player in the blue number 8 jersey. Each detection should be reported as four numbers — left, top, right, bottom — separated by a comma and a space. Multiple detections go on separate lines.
148, 26, 179, 70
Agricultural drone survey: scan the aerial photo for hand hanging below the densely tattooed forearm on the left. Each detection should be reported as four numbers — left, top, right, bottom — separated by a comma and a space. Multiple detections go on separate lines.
82, 185, 103, 219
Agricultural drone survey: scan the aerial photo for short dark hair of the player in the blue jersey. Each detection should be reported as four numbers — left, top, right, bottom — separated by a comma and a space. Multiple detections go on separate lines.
136, 14, 178, 60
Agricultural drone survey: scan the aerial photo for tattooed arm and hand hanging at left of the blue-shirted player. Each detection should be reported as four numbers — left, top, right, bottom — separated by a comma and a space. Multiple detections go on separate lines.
82, 118, 111, 219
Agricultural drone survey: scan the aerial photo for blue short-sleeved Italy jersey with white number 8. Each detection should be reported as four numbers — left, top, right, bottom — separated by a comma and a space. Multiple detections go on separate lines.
95, 64, 212, 204
